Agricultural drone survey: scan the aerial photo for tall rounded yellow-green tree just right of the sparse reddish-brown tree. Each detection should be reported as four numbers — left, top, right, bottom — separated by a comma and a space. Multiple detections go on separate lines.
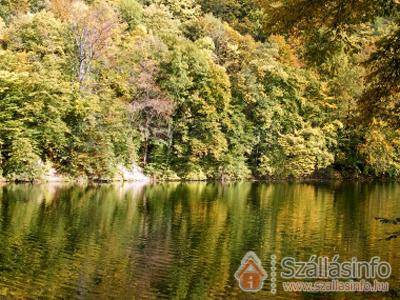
156, 41, 230, 173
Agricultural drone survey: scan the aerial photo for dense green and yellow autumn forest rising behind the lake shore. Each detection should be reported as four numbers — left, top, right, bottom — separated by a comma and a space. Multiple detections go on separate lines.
0, 0, 400, 181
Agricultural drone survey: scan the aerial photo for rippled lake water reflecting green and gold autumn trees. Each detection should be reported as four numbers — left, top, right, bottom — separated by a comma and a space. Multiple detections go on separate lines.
0, 183, 400, 299
